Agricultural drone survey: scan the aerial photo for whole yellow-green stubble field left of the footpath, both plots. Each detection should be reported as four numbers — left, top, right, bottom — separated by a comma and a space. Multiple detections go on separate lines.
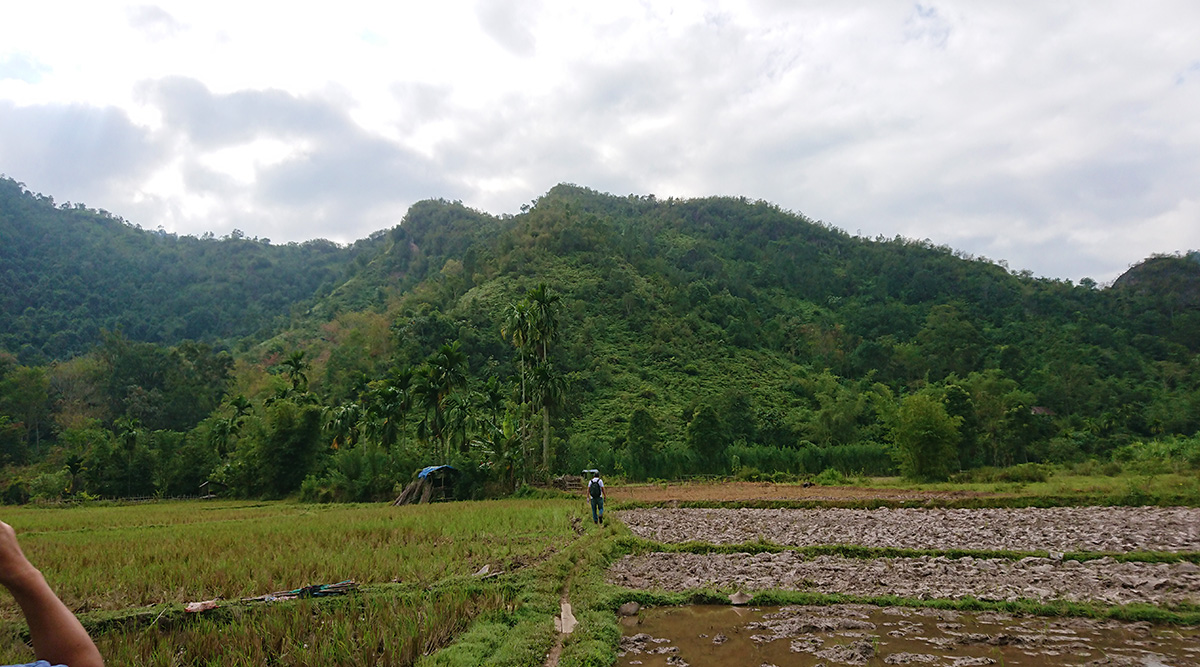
0, 499, 584, 666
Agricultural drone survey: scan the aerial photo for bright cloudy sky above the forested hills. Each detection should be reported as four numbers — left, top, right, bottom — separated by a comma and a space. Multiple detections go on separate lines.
0, 0, 1200, 284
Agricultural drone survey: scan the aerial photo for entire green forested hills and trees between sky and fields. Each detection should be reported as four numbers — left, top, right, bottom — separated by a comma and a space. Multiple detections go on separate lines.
0, 180, 1200, 501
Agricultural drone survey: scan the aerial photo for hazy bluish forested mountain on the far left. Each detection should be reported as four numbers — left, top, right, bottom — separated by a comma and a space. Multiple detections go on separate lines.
0, 179, 361, 362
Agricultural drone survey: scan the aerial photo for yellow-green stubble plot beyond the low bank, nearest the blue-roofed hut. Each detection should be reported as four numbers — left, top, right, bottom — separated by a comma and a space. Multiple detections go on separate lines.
0, 500, 582, 619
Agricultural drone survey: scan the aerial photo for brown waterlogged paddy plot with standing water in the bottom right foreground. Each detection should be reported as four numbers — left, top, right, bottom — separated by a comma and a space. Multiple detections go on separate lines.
617, 605, 1200, 667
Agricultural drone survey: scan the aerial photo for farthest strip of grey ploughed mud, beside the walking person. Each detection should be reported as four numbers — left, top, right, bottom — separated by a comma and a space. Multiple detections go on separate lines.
616, 507, 1200, 552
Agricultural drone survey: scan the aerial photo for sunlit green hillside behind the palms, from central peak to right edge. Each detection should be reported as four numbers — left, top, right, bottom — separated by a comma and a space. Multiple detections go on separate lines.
289, 185, 1200, 475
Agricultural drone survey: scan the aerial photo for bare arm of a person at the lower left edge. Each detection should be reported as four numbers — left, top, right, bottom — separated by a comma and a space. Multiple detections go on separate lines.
0, 521, 104, 667
